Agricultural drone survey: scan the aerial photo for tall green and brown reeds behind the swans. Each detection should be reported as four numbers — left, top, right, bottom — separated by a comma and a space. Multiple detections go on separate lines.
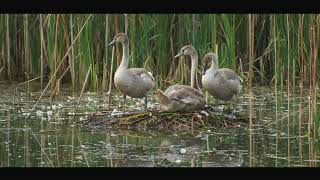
0, 14, 319, 91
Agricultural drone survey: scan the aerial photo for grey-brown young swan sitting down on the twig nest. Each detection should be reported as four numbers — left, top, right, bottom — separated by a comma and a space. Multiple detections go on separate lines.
156, 45, 205, 112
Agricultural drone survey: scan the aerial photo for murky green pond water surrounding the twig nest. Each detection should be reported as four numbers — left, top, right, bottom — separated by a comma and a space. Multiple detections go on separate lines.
0, 82, 320, 167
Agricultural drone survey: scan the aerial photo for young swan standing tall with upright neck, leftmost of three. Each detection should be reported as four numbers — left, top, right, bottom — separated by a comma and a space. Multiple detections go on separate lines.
108, 33, 154, 109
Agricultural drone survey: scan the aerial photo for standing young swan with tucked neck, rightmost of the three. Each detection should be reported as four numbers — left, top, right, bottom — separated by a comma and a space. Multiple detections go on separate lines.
202, 52, 243, 109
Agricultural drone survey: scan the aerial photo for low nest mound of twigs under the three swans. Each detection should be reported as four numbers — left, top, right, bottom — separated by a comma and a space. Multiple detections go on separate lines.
81, 106, 256, 131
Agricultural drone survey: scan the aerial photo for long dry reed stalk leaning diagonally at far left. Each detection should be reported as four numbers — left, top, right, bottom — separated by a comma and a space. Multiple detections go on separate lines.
26, 14, 92, 121
